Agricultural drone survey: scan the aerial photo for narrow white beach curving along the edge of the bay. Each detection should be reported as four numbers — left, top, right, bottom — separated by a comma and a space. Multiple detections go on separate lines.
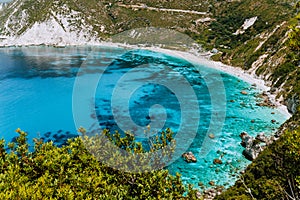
0, 41, 292, 118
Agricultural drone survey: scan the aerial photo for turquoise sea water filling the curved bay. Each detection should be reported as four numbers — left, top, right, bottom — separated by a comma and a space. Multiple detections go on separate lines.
0, 47, 286, 189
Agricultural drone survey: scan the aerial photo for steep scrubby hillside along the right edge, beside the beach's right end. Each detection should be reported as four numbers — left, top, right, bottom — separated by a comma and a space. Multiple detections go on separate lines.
215, 3, 300, 200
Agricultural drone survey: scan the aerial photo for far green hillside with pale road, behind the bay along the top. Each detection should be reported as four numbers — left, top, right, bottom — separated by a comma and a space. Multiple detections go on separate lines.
0, 0, 295, 51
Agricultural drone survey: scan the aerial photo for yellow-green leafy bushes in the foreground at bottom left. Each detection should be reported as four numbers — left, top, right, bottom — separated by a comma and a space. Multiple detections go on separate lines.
0, 129, 195, 199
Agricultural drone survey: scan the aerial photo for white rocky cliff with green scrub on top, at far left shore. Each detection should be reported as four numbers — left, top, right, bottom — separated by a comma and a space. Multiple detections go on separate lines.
0, 0, 114, 44
